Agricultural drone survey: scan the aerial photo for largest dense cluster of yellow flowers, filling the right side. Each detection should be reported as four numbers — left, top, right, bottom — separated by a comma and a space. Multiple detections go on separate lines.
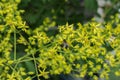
34, 15, 120, 80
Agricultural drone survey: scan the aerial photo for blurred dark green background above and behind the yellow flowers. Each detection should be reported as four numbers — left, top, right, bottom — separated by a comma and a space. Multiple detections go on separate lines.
19, 0, 120, 28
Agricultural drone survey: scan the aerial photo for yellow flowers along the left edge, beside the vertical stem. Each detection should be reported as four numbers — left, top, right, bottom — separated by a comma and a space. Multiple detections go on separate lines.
0, 0, 31, 80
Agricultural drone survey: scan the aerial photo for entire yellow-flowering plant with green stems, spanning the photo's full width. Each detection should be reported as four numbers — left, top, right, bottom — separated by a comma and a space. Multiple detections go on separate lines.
0, 0, 120, 80
